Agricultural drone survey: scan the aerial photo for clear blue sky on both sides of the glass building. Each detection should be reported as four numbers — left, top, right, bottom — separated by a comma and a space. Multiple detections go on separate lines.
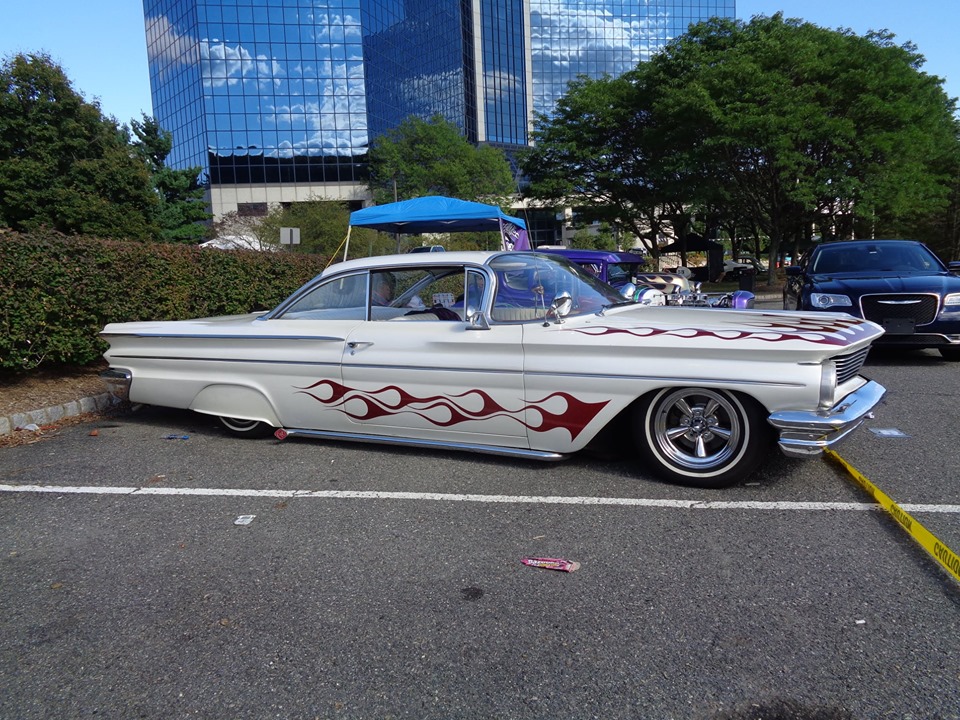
0, 0, 960, 128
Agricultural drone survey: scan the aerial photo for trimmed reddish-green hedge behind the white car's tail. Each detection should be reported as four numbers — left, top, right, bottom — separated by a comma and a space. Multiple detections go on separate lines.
0, 231, 326, 372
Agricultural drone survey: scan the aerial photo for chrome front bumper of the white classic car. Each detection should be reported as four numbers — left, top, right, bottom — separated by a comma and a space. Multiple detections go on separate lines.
767, 380, 886, 458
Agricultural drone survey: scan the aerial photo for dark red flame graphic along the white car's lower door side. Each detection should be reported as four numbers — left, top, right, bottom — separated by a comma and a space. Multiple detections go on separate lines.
297, 380, 609, 441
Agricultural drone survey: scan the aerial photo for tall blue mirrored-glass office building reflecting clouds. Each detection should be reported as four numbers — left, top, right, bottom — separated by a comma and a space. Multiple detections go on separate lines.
144, 0, 735, 215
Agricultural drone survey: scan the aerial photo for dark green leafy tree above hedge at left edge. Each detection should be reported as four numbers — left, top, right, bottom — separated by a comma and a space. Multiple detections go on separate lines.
0, 54, 158, 239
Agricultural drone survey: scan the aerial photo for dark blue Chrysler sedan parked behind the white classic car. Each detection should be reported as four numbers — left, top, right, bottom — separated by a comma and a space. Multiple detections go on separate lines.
783, 240, 960, 360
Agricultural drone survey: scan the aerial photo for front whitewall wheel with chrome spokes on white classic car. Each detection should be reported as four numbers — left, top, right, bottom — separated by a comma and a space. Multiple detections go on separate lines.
634, 388, 772, 488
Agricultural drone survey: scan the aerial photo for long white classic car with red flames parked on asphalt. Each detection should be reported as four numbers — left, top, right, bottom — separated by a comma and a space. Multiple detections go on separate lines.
102, 252, 884, 487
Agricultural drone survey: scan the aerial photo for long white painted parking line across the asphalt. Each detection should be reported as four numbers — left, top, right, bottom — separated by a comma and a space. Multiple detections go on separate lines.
0, 485, 960, 514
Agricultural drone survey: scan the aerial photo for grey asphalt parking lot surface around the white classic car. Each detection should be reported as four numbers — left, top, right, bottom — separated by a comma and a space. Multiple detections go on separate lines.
0, 342, 960, 719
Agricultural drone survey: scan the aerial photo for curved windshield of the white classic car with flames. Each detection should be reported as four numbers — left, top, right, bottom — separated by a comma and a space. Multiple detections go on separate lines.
490, 253, 624, 322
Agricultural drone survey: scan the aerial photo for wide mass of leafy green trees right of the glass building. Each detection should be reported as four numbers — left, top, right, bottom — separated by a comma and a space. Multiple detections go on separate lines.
523, 14, 958, 280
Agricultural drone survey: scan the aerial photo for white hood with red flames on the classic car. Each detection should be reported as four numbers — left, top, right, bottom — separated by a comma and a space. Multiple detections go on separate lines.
562, 306, 883, 356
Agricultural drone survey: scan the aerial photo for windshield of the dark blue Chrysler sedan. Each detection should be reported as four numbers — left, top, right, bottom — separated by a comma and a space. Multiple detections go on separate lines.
810, 242, 943, 275
